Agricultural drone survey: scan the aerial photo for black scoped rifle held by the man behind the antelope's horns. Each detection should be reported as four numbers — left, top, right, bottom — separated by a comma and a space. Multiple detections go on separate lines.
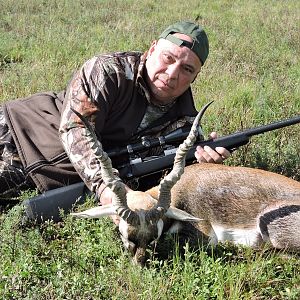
23, 116, 300, 223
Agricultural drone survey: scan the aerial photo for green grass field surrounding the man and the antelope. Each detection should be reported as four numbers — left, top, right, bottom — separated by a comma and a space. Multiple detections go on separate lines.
0, 0, 300, 299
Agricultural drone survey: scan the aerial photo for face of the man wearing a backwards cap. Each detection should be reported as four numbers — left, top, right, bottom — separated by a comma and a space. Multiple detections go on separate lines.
146, 33, 201, 105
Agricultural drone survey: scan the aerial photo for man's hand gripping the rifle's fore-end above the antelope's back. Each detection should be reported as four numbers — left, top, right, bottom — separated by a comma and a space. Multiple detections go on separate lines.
195, 132, 230, 163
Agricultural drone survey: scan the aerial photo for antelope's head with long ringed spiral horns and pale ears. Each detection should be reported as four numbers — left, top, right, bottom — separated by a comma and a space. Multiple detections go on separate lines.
71, 102, 212, 265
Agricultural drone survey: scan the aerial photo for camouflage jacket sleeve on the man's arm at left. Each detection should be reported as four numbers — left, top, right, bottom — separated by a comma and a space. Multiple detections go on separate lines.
59, 58, 117, 193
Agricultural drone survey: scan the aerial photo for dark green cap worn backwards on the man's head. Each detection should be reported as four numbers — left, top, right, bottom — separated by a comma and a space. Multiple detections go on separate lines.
159, 21, 209, 65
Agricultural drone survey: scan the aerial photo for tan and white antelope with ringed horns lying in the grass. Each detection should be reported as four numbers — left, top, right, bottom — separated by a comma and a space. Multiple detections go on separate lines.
72, 110, 300, 264
